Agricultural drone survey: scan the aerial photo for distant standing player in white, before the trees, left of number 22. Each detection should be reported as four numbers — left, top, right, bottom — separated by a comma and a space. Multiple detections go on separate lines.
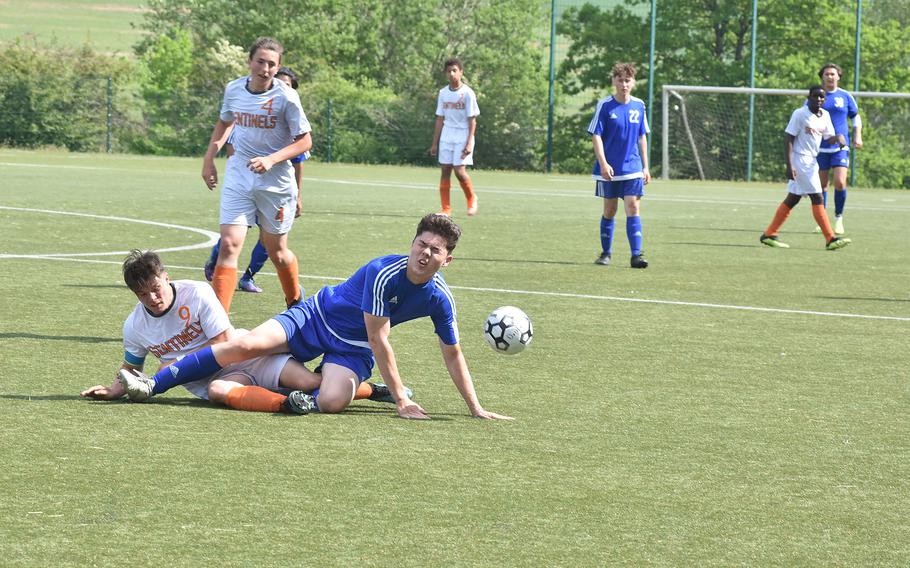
430, 58, 480, 215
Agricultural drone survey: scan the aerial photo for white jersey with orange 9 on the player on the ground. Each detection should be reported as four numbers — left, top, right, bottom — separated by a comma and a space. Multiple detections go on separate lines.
123, 280, 232, 367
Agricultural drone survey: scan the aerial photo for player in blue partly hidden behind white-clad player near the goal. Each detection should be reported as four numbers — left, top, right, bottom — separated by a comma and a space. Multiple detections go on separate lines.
818, 63, 863, 235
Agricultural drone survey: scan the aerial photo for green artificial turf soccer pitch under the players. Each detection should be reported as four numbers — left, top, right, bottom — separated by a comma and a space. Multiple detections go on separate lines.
0, 150, 910, 567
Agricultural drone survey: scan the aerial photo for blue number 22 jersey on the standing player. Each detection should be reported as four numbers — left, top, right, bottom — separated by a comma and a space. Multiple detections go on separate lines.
588, 96, 651, 181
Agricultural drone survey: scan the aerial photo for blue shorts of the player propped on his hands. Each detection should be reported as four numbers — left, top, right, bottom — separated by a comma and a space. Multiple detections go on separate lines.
273, 296, 375, 382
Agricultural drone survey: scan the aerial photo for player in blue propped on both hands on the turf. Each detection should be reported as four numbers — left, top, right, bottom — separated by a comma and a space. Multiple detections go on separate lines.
121, 214, 509, 420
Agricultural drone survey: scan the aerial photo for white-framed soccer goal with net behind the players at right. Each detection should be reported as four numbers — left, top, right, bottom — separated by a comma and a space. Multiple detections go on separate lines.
661, 85, 910, 189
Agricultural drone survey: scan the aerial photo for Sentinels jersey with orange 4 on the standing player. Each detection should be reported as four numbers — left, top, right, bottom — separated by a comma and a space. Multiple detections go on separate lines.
220, 77, 311, 162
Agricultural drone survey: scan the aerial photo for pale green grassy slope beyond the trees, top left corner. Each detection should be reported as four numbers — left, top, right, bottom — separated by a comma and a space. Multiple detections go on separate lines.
0, 0, 145, 55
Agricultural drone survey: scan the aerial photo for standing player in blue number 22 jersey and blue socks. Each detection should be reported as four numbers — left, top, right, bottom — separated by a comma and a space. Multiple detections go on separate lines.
588, 63, 651, 268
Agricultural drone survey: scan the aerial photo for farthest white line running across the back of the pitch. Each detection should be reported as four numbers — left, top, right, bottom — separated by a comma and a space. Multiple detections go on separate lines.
0, 162, 910, 212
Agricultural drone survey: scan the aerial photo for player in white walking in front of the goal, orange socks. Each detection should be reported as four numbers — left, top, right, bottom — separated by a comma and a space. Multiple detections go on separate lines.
759, 85, 850, 250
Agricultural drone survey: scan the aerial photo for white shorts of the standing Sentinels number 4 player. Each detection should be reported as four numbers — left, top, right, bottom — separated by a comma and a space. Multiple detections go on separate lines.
219, 155, 297, 235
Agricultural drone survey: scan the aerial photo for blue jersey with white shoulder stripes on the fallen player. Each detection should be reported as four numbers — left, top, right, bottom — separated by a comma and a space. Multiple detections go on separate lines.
316, 254, 458, 347
